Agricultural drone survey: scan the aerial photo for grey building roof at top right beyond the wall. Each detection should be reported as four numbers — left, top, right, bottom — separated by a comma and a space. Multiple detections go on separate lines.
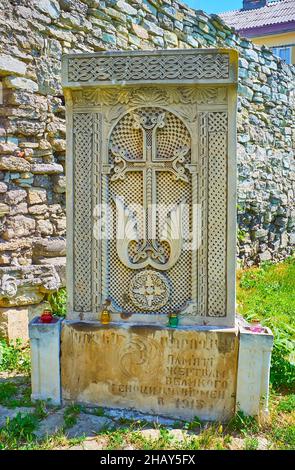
218, 0, 295, 31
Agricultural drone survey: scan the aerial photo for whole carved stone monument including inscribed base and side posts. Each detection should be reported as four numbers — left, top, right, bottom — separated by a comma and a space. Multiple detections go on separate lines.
30, 49, 272, 420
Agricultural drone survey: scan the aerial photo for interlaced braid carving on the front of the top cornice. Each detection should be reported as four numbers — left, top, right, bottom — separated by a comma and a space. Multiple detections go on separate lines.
67, 52, 229, 84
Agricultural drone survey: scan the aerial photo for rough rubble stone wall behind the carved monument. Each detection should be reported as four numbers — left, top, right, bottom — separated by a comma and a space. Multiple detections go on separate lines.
0, 0, 295, 333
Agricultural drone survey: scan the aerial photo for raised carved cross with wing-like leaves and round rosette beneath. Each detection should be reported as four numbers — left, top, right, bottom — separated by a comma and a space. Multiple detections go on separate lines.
107, 110, 193, 310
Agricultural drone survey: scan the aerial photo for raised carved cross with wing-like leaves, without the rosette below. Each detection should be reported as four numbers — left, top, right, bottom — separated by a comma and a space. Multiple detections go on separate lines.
111, 112, 192, 270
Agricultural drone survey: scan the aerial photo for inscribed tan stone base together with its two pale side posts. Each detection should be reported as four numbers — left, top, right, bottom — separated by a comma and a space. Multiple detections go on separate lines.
30, 320, 273, 421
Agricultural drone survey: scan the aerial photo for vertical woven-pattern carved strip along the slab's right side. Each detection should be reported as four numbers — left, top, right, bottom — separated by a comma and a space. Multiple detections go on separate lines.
198, 112, 228, 317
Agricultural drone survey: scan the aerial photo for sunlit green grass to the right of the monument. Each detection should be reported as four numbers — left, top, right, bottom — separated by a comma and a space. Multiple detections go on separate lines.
237, 258, 295, 391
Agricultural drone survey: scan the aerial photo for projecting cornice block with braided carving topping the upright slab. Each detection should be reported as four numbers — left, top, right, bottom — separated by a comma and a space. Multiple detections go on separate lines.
63, 49, 236, 86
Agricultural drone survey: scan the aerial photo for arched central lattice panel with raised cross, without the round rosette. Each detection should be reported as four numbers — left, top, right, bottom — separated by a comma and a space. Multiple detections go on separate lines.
103, 106, 197, 313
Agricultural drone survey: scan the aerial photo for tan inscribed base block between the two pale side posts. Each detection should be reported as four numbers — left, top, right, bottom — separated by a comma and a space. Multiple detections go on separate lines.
61, 322, 238, 420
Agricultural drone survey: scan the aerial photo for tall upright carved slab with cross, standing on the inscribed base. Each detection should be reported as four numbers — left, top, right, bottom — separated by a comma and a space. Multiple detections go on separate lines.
63, 49, 237, 327
